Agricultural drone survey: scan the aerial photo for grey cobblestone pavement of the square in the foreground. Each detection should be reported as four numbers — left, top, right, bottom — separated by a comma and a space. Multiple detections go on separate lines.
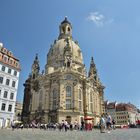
0, 129, 140, 140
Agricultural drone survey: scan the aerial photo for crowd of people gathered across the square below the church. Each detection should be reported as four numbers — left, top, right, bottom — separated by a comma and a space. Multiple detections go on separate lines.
11, 113, 140, 133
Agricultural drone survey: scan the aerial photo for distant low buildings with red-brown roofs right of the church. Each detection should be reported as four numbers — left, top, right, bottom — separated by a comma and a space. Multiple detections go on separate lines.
105, 101, 139, 125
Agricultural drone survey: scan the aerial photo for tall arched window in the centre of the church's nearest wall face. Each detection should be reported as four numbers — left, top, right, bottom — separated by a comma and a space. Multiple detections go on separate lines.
66, 86, 72, 109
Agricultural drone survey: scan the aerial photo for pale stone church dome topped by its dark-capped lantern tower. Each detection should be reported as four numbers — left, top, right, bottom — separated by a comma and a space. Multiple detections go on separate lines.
47, 18, 83, 72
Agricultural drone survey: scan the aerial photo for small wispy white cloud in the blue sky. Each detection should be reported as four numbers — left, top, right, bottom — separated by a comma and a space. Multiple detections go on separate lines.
87, 12, 114, 27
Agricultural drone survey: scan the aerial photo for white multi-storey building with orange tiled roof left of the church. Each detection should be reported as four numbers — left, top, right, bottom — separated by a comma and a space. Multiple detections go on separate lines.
0, 43, 20, 128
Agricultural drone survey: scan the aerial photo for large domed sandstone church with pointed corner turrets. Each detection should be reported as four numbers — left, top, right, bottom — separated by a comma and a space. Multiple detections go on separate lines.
22, 18, 104, 124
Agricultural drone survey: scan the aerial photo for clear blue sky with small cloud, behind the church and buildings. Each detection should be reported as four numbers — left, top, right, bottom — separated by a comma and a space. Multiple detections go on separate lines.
0, 0, 140, 107
